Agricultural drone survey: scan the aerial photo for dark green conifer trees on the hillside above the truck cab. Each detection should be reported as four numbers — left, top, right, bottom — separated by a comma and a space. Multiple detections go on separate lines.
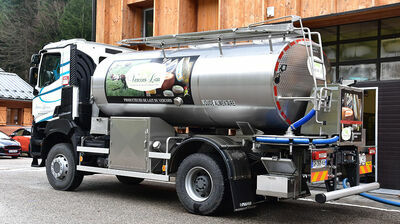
0, 0, 91, 80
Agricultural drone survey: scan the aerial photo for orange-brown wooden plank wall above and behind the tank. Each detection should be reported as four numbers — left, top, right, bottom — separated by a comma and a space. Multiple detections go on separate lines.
96, 0, 400, 44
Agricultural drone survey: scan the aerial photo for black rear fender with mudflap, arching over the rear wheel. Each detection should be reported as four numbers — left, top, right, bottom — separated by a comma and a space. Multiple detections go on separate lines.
170, 136, 256, 211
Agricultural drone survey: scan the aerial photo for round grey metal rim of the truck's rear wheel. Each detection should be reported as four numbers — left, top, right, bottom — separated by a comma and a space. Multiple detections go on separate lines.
185, 166, 213, 202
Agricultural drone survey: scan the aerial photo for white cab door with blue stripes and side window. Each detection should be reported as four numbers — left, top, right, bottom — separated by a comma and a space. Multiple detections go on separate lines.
32, 46, 70, 123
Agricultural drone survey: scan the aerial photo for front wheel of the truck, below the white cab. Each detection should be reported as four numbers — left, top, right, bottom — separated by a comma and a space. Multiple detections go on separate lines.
46, 143, 83, 191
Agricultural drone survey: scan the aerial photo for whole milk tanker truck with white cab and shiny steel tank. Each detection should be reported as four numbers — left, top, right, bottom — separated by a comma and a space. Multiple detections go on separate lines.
30, 16, 379, 215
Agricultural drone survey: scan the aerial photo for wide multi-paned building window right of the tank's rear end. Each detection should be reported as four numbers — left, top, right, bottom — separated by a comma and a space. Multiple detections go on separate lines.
316, 17, 400, 81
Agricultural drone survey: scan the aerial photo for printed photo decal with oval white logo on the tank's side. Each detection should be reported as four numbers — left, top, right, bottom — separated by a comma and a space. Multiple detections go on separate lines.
105, 56, 199, 104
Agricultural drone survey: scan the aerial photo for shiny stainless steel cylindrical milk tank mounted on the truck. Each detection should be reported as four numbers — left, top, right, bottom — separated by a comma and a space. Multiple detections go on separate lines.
92, 38, 324, 132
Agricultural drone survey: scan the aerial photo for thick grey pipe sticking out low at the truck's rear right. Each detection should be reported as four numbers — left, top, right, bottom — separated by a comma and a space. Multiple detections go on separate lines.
315, 182, 380, 203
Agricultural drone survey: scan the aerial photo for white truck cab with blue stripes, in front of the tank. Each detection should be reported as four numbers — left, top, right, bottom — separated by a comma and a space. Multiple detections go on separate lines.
30, 39, 133, 158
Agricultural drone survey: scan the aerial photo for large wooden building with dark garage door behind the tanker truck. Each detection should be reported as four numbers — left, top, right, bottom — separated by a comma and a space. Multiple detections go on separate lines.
96, 0, 400, 189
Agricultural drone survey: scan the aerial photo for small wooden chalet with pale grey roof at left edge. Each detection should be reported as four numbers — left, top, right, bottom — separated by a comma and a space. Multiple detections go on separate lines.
0, 69, 33, 134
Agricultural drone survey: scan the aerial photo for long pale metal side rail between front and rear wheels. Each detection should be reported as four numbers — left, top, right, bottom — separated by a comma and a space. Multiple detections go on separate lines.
76, 165, 170, 182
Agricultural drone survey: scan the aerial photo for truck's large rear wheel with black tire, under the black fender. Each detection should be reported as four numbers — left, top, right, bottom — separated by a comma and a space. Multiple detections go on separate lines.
176, 153, 229, 215
